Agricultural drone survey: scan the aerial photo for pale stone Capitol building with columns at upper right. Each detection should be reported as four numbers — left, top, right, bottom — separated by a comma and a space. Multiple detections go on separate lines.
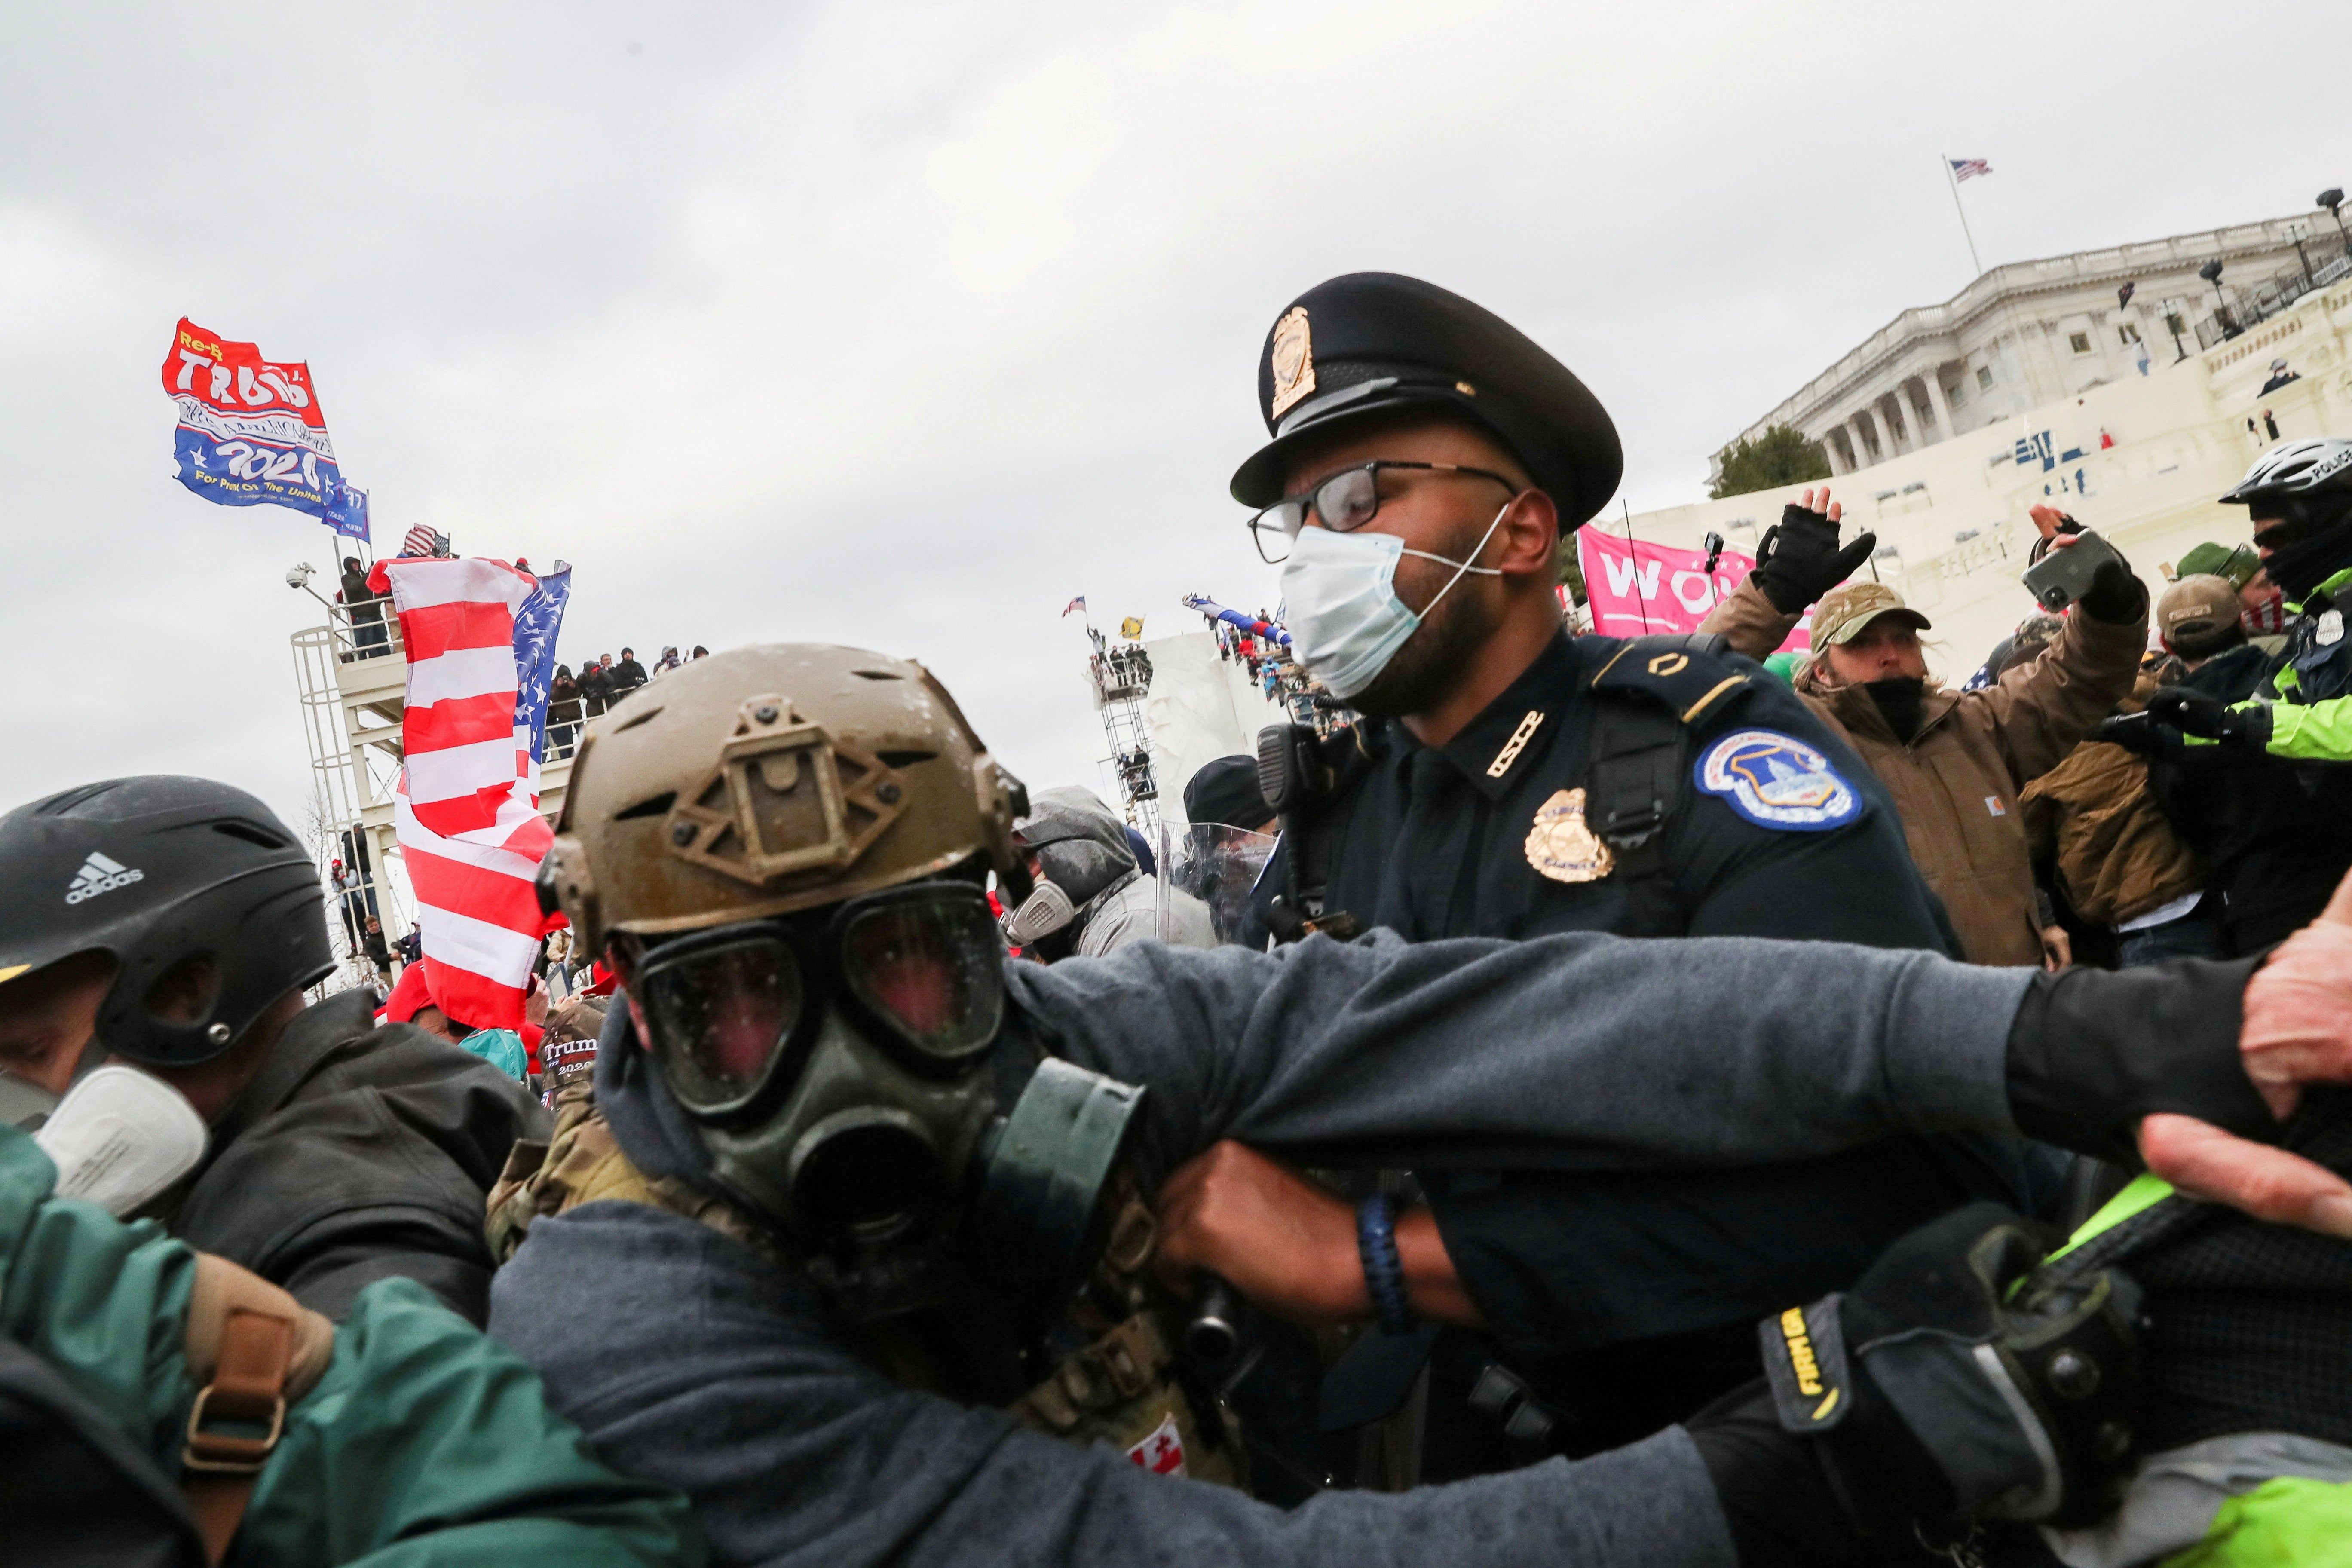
1627, 211, 2352, 682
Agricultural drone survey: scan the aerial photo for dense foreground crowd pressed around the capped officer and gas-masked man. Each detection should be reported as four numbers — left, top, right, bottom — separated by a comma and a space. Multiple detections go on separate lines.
14, 273, 2352, 1568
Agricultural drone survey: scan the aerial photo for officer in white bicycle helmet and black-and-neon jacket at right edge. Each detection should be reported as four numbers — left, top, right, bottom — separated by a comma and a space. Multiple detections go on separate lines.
2100, 437, 2352, 952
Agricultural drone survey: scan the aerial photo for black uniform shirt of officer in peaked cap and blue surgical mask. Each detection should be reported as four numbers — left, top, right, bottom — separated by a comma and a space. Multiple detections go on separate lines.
1261, 637, 1959, 957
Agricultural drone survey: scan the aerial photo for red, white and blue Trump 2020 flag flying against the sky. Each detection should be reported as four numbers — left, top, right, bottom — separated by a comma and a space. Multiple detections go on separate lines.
162, 317, 367, 541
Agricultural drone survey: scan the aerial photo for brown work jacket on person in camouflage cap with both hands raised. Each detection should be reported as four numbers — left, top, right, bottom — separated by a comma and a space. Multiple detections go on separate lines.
1700, 578, 2147, 966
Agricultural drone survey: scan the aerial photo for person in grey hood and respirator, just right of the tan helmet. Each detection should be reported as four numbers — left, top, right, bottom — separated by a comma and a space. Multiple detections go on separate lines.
1004, 785, 1216, 962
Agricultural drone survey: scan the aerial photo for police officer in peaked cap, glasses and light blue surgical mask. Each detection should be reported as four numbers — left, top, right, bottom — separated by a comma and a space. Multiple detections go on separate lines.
1232, 273, 2037, 1474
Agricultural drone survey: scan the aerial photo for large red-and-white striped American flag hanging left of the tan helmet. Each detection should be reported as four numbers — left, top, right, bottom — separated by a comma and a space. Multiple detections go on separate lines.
367, 557, 569, 1030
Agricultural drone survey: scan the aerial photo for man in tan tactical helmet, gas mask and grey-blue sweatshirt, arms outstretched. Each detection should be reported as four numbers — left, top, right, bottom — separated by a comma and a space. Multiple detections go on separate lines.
492, 644, 2352, 1566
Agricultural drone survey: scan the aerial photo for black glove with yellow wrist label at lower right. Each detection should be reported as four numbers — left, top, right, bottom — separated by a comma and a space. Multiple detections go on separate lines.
1689, 1204, 2141, 1563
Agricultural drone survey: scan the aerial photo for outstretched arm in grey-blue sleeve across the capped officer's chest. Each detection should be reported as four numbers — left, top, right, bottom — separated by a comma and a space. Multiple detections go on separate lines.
1009, 893, 2352, 1234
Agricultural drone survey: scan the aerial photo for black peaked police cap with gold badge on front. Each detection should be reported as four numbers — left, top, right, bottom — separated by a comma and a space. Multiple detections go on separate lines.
1232, 273, 1625, 531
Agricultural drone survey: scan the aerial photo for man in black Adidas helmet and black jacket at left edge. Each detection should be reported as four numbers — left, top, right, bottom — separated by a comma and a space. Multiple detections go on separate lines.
0, 776, 546, 1323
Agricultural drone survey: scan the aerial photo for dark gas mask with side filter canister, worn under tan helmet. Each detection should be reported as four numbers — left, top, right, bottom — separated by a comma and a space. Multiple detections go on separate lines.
630, 882, 1143, 1319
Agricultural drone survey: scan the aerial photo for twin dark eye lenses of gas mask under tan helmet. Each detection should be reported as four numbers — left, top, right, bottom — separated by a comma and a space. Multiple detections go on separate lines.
635, 882, 1004, 1119
